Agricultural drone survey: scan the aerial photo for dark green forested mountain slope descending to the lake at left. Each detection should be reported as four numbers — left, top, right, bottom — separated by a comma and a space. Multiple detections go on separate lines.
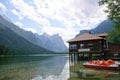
0, 23, 53, 55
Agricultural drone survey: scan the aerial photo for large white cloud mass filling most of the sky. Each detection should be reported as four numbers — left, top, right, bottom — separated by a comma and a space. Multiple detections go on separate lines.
11, 0, 106, 41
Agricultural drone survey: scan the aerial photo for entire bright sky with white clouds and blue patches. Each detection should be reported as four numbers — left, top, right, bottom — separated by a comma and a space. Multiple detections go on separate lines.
0, 0, 107, 45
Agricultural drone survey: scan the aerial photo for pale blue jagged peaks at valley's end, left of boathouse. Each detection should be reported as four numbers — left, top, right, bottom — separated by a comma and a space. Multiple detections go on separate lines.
36, 33, 67, 52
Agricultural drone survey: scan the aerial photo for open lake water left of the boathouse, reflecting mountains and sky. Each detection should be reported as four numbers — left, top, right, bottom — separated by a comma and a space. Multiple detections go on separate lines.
0, 55, 69, 80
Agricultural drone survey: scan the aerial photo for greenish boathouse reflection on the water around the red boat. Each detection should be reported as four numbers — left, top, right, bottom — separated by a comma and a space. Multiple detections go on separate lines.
68, 61, 120, 80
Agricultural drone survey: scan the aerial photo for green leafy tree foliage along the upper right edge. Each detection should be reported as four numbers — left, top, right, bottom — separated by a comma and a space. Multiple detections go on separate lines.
99, 0, 120, 44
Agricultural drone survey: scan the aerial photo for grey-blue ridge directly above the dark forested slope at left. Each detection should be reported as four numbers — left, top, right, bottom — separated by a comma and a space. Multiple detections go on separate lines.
0, 15, 37, 45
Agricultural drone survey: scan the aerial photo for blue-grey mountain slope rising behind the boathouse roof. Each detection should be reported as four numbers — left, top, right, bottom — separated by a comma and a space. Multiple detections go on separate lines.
78, 20, 114, 35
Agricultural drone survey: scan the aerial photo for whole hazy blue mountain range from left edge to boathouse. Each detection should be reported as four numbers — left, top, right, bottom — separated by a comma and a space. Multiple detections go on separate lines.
0, 15, 67, 52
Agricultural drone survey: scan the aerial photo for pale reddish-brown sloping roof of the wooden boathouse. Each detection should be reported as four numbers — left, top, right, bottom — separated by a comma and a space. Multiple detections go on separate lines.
67, 33, 107, 43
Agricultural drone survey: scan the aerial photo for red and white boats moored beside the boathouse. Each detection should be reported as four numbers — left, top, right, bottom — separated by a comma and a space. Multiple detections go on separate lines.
83, 59, 120, 70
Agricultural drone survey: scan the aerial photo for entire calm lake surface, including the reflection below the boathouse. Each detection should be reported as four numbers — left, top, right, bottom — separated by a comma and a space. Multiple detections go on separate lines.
0, 55, 120, 80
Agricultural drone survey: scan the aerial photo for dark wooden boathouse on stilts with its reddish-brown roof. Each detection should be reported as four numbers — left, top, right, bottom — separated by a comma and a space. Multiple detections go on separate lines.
68, 33, 120, 60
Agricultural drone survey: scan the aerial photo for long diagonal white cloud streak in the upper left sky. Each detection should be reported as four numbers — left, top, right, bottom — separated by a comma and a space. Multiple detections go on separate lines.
11, 0, 50, 26
